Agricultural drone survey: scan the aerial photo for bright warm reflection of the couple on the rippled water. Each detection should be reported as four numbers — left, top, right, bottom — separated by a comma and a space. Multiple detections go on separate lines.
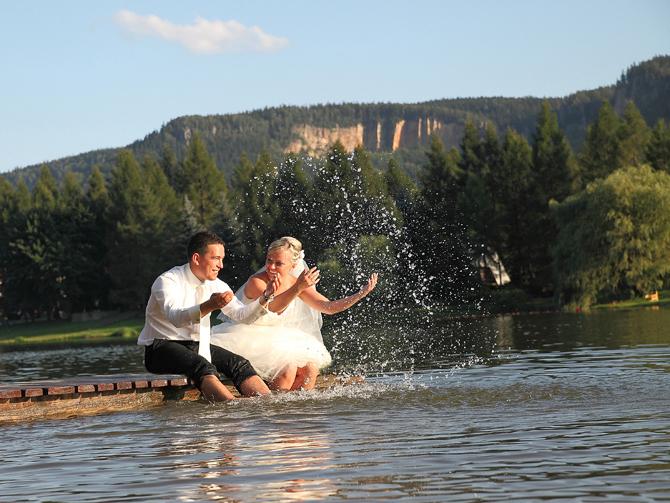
142, 397, 342, 501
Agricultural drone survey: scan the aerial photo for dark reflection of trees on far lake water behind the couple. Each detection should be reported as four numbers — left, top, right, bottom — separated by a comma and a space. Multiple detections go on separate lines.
0, 308, 670, 383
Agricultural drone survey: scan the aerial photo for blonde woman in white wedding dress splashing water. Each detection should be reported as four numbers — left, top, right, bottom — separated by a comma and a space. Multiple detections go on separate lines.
212, 237, 377, 391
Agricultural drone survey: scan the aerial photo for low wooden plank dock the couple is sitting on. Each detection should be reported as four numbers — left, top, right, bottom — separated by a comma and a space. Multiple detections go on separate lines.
0, 374, 362, 424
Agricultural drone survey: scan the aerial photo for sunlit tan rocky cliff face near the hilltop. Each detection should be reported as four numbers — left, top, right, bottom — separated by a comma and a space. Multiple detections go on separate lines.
284, 117, 446, 156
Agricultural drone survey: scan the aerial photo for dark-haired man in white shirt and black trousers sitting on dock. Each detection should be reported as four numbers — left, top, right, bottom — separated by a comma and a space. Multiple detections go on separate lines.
137, 231, 277, 401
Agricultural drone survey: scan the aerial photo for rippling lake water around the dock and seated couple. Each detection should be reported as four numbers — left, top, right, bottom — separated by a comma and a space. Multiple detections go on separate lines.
0, 309, 670, 502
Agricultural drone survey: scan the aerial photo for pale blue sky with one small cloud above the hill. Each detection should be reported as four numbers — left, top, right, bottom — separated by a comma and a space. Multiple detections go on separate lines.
0, 0, 670, 171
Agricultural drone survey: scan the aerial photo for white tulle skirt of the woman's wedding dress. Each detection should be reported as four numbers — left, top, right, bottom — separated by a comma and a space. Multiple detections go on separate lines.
211, 323, 332, 381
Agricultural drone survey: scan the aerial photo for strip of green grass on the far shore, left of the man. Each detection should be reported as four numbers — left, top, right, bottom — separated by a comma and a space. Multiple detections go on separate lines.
0, 313, 144, 348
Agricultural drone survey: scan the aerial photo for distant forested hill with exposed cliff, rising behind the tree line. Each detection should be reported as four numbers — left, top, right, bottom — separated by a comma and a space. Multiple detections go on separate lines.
4, 56, 670, 187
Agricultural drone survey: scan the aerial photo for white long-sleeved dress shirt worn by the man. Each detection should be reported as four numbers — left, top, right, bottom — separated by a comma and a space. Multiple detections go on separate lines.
137, 264, 266, 346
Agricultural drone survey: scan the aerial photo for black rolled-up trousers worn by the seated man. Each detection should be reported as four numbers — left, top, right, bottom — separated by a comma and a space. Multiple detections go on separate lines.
144, 339, 256, 391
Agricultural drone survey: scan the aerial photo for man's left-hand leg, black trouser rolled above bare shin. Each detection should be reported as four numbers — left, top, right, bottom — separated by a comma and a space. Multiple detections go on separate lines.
144, 339, 235, 402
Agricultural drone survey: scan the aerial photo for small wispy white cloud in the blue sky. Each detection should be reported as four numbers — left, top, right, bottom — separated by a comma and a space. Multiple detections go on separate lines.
114, 10, 288, 54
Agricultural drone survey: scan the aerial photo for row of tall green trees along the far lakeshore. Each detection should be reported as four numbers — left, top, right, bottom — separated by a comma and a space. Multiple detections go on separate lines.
0, 102, 670, 318
